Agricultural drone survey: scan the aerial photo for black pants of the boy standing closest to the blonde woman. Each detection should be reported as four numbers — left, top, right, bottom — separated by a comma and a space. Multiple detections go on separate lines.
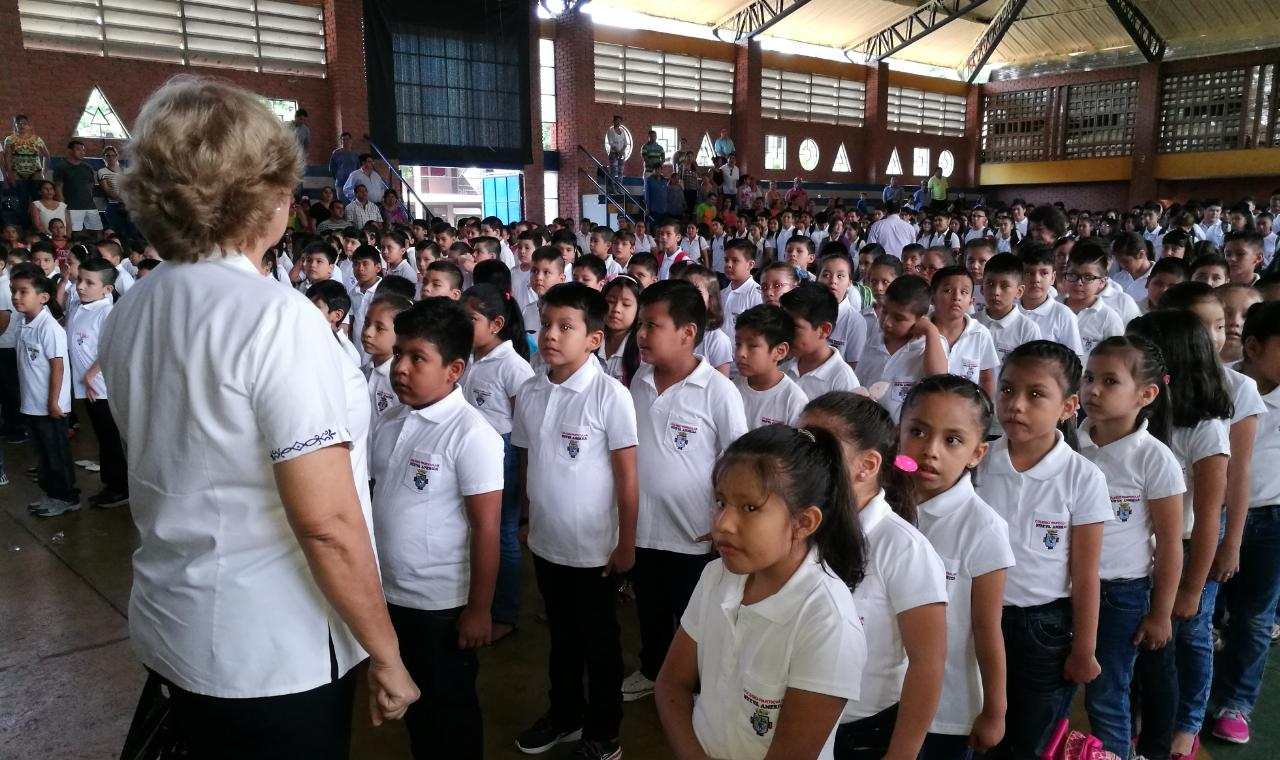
387, 604, 484, 760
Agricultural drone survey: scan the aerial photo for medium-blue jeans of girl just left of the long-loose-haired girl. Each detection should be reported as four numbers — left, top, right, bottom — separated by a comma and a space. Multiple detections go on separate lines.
1084, 578, 1151, 757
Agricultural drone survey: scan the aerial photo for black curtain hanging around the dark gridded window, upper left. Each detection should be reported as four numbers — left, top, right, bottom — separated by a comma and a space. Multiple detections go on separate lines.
364, 0, 538, 168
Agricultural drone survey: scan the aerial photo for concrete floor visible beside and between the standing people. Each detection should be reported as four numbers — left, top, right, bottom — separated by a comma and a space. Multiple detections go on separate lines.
0, 425, 1280, 760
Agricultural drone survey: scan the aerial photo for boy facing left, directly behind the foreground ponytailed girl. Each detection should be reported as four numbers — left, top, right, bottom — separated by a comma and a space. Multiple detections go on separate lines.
622, 280, 746, 701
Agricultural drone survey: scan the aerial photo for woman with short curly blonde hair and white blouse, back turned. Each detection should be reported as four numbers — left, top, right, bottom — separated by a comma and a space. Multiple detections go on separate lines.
100, 75, 419, 760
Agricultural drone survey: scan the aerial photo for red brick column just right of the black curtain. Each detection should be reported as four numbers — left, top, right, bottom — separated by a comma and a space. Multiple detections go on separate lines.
556, 10, 593, 218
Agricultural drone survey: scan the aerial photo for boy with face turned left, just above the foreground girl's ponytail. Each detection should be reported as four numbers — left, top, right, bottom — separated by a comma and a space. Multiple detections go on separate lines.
780, 283, 858, 398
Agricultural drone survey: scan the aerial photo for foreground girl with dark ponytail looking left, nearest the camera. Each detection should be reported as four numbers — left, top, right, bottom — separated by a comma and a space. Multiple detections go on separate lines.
657, 425, 867, 760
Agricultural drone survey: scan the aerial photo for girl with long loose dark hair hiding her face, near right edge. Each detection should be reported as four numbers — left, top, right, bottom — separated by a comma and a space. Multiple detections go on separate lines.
1128, 311, 1234, 757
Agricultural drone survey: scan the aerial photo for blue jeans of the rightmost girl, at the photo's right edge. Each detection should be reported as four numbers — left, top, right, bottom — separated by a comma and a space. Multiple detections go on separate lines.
1219, 505, 1280, 715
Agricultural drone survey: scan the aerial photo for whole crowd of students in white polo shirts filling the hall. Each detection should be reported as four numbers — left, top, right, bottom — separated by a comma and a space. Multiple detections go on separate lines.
0, 180, 1280, 760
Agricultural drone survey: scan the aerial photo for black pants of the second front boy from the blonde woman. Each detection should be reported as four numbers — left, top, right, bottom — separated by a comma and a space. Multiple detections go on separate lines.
534, 554, 622, 741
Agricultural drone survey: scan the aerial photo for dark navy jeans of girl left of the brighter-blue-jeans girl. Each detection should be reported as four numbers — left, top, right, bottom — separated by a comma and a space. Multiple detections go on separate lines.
987, 599, 1075, 760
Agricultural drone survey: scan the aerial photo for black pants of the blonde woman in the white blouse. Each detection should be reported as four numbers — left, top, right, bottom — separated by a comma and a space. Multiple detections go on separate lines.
138, 668, 356, 760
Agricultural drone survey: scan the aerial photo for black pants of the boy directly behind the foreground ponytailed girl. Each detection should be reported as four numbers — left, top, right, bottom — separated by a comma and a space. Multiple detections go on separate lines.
631, 549, 712, 681
